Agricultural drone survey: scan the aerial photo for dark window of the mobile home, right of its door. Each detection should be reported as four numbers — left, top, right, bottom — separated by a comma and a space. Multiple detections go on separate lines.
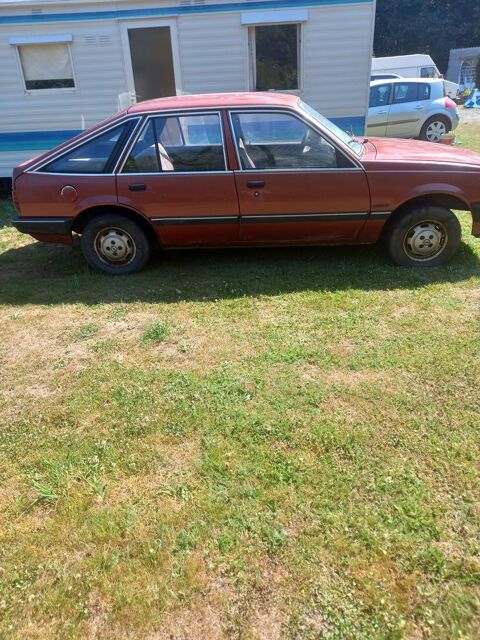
250, 24, 301, 91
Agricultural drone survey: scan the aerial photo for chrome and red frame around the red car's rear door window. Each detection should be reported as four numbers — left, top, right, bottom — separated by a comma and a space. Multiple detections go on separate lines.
114, 108, 232, 176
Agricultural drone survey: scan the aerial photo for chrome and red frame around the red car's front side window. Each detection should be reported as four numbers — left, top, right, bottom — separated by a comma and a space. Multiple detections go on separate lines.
228, 107, 364, 173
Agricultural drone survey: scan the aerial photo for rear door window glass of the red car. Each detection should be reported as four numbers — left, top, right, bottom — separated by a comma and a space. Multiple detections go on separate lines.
123, 114, 225, 173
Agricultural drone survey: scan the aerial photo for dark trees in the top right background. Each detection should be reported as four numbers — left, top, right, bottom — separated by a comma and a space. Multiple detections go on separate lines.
374, 0, 480, 73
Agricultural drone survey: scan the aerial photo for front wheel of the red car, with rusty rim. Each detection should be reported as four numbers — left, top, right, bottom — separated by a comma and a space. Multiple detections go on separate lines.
385, 205, 462, 267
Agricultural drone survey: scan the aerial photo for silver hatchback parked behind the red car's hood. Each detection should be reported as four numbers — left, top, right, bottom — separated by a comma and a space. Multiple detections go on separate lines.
367, 78, 460, 142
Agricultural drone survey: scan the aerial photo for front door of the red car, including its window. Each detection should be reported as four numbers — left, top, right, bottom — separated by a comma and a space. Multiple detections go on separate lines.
230, 110, 370, 244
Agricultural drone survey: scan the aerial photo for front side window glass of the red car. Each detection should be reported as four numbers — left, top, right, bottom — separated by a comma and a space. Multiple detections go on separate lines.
232, 112, 340, 170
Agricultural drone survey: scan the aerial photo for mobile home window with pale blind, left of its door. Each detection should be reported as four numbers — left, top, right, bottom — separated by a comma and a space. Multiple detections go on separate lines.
18, 42, 75, 91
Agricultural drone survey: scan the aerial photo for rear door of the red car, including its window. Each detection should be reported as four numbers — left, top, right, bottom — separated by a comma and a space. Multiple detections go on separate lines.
117, 112, 239, 247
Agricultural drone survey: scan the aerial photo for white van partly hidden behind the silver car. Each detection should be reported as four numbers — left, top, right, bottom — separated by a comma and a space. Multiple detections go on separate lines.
371, 53, 459, 98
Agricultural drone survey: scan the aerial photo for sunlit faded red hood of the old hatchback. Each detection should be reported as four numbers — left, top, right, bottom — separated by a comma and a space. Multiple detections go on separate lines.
363, 138, 480, 168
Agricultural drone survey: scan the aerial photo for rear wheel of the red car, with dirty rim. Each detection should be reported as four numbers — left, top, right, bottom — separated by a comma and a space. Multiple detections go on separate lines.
81, 214, 152, 275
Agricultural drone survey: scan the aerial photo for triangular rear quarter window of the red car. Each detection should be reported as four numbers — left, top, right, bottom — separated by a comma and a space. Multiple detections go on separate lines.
40, 122, 133, 173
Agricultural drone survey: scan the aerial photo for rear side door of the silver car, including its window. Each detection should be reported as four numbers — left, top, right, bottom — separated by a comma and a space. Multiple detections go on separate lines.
387, 82, 429, 138
